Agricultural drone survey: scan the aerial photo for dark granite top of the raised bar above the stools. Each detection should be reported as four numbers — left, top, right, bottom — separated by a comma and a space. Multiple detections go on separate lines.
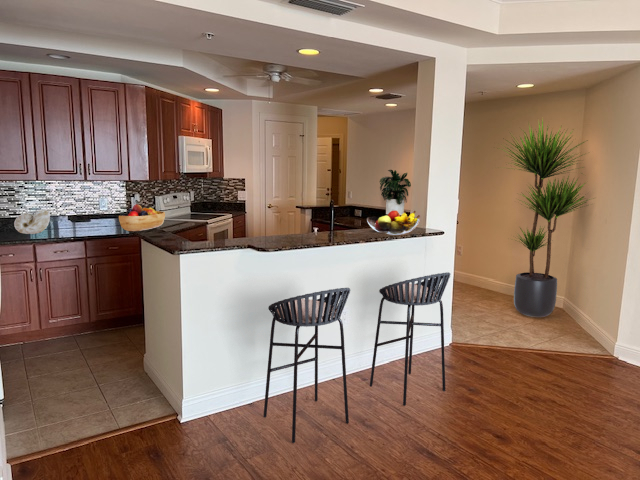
138, 228, 444, 255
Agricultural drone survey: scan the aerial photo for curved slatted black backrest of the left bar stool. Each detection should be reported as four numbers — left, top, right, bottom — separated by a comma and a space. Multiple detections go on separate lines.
269, 288, 351, 326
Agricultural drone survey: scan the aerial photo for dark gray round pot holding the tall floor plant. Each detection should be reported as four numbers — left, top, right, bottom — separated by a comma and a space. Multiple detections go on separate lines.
513, 273, 558, 317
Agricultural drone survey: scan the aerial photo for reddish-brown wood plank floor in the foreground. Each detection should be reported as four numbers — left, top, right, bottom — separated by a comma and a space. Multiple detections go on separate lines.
13, 346, 640, 480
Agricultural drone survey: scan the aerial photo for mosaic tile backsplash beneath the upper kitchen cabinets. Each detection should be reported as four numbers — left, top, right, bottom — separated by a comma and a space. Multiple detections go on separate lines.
0, 177, 245, 217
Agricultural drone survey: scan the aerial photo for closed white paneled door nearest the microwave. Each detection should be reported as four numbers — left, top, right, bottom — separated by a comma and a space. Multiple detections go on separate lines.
265, 120, 304, 235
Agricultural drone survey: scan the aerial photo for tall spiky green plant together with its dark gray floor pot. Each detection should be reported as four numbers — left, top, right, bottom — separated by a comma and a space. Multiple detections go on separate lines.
505, 122, 587, 317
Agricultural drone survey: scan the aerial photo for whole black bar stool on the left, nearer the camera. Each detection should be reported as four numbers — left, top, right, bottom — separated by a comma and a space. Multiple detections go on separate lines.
264, 288, 350, 443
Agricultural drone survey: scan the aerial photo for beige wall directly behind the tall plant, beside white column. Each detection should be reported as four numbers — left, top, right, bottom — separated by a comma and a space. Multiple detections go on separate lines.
456, 90, 585, 296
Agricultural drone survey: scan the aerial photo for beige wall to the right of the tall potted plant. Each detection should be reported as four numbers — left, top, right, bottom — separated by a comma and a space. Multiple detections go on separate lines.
566, 67, 640, 342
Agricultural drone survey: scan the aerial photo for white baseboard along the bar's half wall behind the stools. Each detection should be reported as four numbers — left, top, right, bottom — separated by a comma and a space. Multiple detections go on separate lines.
178, 330, 451, 422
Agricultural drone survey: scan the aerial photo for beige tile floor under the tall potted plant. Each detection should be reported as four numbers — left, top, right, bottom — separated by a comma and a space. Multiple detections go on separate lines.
452, 282, 609, 355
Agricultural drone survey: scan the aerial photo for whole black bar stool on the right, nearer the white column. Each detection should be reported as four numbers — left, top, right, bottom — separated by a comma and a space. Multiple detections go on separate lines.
369, 273, 450, 405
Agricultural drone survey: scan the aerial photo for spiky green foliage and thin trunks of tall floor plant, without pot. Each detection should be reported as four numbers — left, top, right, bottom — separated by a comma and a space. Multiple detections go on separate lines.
506, 122, 587, 278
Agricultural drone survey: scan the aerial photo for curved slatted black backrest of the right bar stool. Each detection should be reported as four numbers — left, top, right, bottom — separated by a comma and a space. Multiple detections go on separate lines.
380, 273, 451, 305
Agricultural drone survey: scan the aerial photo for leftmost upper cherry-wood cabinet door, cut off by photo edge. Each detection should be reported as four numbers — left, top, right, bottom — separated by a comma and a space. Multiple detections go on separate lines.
0, 72, 36, 180
